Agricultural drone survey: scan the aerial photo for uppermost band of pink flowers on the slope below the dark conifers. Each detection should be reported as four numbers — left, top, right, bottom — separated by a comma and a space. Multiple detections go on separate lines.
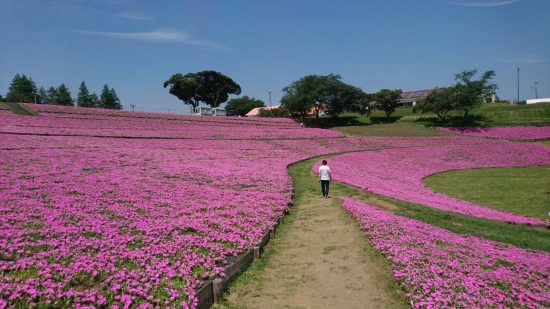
0, 104, 343, 139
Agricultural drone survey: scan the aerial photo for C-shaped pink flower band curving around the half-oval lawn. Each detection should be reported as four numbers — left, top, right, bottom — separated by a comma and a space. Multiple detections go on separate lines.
313, 142, 550, 225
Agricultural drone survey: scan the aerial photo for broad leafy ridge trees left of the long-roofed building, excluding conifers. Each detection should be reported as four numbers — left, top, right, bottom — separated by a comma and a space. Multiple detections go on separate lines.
164, 71, 401, 117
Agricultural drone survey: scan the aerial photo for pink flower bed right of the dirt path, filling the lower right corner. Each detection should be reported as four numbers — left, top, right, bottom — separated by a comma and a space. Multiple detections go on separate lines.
341, 198, 550, 308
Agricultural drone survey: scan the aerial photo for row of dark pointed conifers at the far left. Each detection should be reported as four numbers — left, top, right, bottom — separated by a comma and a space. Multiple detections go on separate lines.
0, 74, 122, 109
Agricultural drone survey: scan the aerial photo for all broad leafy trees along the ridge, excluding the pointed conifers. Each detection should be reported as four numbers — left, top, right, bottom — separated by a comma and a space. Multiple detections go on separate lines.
164, 70, 497, 120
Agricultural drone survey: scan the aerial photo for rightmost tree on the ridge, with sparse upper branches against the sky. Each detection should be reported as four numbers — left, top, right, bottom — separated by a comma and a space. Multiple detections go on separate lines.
453, 70, 498, 118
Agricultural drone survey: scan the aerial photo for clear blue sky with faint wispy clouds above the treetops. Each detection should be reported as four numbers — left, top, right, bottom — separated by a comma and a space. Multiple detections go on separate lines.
0, 0, 550, 112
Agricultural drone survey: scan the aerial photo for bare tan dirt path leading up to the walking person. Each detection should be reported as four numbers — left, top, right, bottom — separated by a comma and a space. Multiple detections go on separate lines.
223, 183, 404, 308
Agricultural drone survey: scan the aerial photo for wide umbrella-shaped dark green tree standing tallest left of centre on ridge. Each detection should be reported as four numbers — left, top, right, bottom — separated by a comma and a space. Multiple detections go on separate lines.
164, 71, 241, 112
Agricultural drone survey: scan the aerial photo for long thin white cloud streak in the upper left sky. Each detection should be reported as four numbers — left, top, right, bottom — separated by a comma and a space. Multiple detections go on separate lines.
69, 30, 229, 51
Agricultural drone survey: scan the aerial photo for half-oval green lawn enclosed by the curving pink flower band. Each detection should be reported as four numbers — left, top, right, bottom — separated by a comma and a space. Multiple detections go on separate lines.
424, 165, 550, 219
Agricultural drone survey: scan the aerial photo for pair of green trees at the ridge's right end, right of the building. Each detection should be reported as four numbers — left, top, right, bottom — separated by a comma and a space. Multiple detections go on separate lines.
415, 70, 498, 120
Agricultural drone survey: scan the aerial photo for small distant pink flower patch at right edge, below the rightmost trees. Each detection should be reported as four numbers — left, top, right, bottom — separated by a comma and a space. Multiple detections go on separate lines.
438, 126, 550, 140
